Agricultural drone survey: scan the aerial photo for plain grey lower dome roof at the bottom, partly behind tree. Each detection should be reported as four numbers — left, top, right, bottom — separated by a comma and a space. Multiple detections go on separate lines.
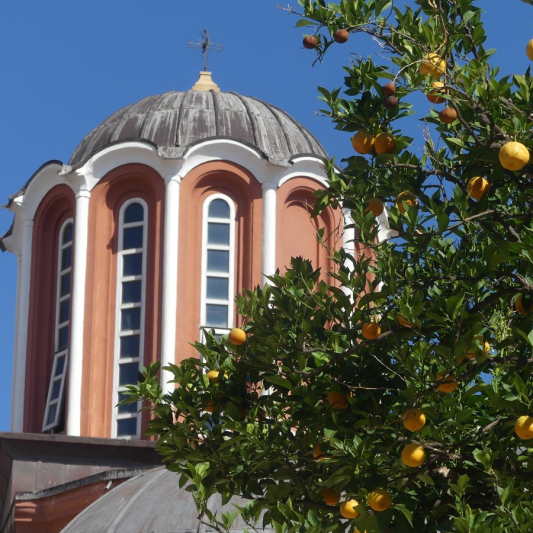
62, 468, 274, 533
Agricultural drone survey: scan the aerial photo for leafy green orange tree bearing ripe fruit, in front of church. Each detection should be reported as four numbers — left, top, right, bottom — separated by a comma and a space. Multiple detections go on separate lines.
131, 0, 533, 532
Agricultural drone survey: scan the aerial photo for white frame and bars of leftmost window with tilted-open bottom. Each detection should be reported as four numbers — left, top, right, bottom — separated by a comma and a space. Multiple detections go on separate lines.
42, 218, 74, 431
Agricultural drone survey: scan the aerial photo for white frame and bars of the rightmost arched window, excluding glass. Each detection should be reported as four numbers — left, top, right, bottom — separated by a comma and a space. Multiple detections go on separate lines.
200, 193, 237, 342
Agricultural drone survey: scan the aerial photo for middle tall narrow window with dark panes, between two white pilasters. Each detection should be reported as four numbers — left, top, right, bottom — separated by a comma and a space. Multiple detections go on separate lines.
113, 198, 148, 439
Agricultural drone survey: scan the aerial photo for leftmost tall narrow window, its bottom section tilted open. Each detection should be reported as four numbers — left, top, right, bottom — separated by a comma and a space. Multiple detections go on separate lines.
43, 219, 72, 431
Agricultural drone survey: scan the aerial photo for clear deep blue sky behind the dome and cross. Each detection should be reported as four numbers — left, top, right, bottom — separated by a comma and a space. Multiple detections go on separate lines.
0, 0, 533, 431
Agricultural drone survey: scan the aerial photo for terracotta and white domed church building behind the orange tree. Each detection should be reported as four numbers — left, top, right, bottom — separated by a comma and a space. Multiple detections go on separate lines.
0, 71, 358, 533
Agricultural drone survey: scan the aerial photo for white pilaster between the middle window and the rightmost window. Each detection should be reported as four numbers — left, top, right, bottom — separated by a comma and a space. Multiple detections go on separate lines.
161, 176, 180, 393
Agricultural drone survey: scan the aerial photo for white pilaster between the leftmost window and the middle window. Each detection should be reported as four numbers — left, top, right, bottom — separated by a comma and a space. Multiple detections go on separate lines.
66, 190, 91, 436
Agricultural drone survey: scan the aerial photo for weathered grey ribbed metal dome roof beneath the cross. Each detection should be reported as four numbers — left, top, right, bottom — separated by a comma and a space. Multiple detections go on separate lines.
69, 90, 327, 168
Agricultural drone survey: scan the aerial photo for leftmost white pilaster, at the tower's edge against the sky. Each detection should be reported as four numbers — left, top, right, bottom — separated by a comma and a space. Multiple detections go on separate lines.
11, 220, 33, 433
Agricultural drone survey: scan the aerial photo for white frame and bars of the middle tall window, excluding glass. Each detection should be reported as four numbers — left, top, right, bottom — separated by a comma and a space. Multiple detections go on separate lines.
111, 198, 149, 440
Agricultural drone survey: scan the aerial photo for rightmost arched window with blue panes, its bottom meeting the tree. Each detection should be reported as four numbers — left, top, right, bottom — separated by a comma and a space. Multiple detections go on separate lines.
200, 194, 235, 335
